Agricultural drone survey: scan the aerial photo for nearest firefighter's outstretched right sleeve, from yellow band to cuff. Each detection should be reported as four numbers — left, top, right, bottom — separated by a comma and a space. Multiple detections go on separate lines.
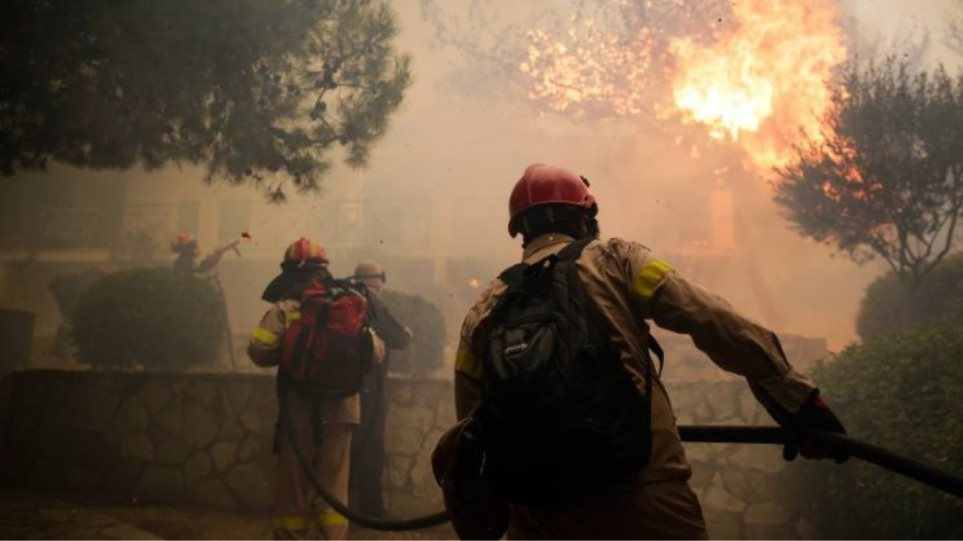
629, 243, 815, 412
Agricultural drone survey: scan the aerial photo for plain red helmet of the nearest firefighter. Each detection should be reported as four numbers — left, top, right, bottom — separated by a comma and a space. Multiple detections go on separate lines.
508, 163, 598, 237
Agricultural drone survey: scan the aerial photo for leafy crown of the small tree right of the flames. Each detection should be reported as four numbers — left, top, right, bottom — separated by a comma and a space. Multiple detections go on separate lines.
775, 59, 963, 285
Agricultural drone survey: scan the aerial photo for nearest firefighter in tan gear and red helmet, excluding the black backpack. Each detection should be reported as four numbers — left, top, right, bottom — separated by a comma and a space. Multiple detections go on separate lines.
448, 164, 846, 539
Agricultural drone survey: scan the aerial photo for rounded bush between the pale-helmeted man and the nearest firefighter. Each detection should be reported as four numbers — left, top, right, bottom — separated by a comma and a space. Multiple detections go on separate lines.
384, 290, 445, 376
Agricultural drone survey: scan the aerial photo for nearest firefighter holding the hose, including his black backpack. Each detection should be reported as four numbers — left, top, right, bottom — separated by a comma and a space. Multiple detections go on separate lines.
434, 164, 846, 539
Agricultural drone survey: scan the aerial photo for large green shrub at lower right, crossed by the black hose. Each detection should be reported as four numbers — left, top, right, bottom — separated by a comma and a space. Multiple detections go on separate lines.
785, 324, 963, 539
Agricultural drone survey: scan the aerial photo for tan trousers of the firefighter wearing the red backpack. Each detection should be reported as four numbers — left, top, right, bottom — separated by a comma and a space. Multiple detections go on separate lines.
274, 393, 356, 539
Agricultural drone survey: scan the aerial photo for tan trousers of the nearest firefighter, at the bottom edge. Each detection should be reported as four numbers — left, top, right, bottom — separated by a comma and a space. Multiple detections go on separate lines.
506, 481, 708, 539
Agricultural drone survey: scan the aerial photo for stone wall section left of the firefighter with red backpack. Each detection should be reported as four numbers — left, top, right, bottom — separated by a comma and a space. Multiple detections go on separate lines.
0, 371, 276, 509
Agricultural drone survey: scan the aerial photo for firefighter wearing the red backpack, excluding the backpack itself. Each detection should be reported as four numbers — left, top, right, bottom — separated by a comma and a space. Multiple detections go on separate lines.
247, 238, 361, 539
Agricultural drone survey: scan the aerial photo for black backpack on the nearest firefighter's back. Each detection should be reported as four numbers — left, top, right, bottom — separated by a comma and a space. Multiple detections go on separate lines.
473, 239, 661, 505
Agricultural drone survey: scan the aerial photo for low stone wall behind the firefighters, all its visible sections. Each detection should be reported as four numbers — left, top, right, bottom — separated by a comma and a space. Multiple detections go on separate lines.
0, 371, 809, 539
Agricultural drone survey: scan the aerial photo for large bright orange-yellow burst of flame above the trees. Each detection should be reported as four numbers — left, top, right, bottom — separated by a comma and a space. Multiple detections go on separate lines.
669, 0, 846, 168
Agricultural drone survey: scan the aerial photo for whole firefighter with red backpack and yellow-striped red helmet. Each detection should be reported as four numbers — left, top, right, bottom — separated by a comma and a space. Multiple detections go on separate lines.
248, 238, 383, 539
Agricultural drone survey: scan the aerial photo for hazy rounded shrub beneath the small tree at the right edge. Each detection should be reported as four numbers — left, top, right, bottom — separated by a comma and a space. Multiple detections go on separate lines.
856, 254, 963, 340
